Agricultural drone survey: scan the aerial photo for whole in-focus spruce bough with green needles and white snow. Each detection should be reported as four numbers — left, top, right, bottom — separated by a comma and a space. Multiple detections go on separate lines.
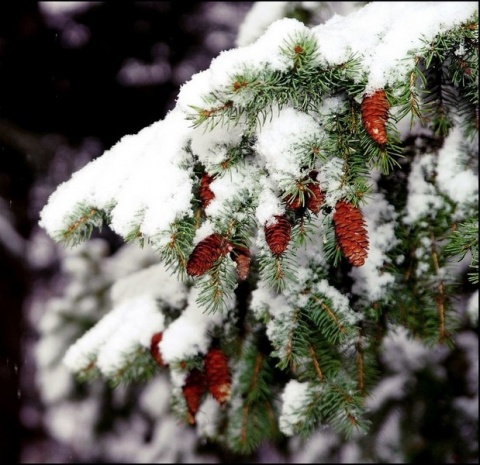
36, 2, 478, 454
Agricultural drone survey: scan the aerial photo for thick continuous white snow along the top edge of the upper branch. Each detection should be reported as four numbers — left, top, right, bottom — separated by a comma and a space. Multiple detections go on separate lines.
39, 2, 477, 243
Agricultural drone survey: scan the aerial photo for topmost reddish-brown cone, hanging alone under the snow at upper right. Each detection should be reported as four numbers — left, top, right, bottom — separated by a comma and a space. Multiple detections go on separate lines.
361, 89, 389, 145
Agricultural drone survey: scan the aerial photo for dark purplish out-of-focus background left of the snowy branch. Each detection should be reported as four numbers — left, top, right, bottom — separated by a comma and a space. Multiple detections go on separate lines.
0, 1, 252, 463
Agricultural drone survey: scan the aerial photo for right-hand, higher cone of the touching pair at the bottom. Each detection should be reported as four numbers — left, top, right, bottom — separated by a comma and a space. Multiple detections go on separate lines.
203, 348, 231, 405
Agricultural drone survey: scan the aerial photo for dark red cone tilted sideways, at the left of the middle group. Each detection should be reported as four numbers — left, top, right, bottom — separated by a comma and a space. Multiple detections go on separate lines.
187, 233, 232, 276
